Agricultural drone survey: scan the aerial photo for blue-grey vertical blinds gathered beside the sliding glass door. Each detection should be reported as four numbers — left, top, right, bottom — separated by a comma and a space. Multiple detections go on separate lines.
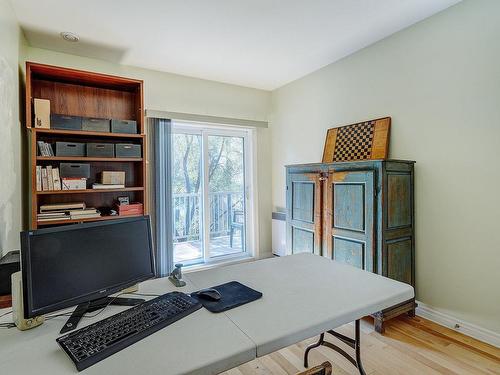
148, 118, 173, 277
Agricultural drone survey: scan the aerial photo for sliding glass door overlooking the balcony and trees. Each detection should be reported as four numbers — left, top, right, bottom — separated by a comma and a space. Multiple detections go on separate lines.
172, 122, 253, 265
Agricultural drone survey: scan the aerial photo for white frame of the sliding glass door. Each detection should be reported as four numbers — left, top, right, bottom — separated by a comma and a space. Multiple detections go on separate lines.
172, 119, 259, 271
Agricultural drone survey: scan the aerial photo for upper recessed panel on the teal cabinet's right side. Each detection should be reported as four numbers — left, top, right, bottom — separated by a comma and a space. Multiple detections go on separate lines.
387, 172, 412, 229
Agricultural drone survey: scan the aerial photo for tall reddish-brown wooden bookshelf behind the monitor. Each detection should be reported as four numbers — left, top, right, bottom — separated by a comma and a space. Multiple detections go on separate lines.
26, 62, 147, 229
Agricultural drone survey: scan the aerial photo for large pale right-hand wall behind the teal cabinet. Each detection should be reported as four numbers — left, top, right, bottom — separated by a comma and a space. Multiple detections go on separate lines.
271, 0, 500, 332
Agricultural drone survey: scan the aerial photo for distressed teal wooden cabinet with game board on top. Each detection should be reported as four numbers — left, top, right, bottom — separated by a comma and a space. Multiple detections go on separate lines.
286, 160, 415, 332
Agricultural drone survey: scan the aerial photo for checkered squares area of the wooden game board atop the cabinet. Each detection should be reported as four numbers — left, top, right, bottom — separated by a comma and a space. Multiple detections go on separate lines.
333, 121, 375, 161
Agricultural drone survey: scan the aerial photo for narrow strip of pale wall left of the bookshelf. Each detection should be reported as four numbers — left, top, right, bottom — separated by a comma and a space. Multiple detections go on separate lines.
0, 0, 22, 255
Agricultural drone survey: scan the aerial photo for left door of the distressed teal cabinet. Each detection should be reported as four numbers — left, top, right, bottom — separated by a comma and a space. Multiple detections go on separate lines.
286, 173, 321, 254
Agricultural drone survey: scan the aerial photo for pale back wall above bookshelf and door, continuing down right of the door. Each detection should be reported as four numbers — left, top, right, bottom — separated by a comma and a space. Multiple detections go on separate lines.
16, 42, 271, 257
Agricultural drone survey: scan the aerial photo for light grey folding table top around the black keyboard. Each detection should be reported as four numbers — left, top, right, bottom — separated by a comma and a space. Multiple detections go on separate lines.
0, 254, 414, 375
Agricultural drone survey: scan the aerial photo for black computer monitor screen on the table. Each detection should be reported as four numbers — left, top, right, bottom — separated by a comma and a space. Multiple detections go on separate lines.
21, 217, 154, 317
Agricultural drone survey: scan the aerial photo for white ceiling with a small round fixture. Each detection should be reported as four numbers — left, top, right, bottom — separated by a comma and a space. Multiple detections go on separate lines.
11, 0, 460, 90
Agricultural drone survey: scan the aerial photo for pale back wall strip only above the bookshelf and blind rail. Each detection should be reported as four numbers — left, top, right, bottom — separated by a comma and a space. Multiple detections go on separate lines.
25, 47, 270, 121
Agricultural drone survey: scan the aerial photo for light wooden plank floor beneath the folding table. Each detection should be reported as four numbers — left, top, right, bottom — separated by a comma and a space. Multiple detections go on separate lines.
223, 317, 500, 375
